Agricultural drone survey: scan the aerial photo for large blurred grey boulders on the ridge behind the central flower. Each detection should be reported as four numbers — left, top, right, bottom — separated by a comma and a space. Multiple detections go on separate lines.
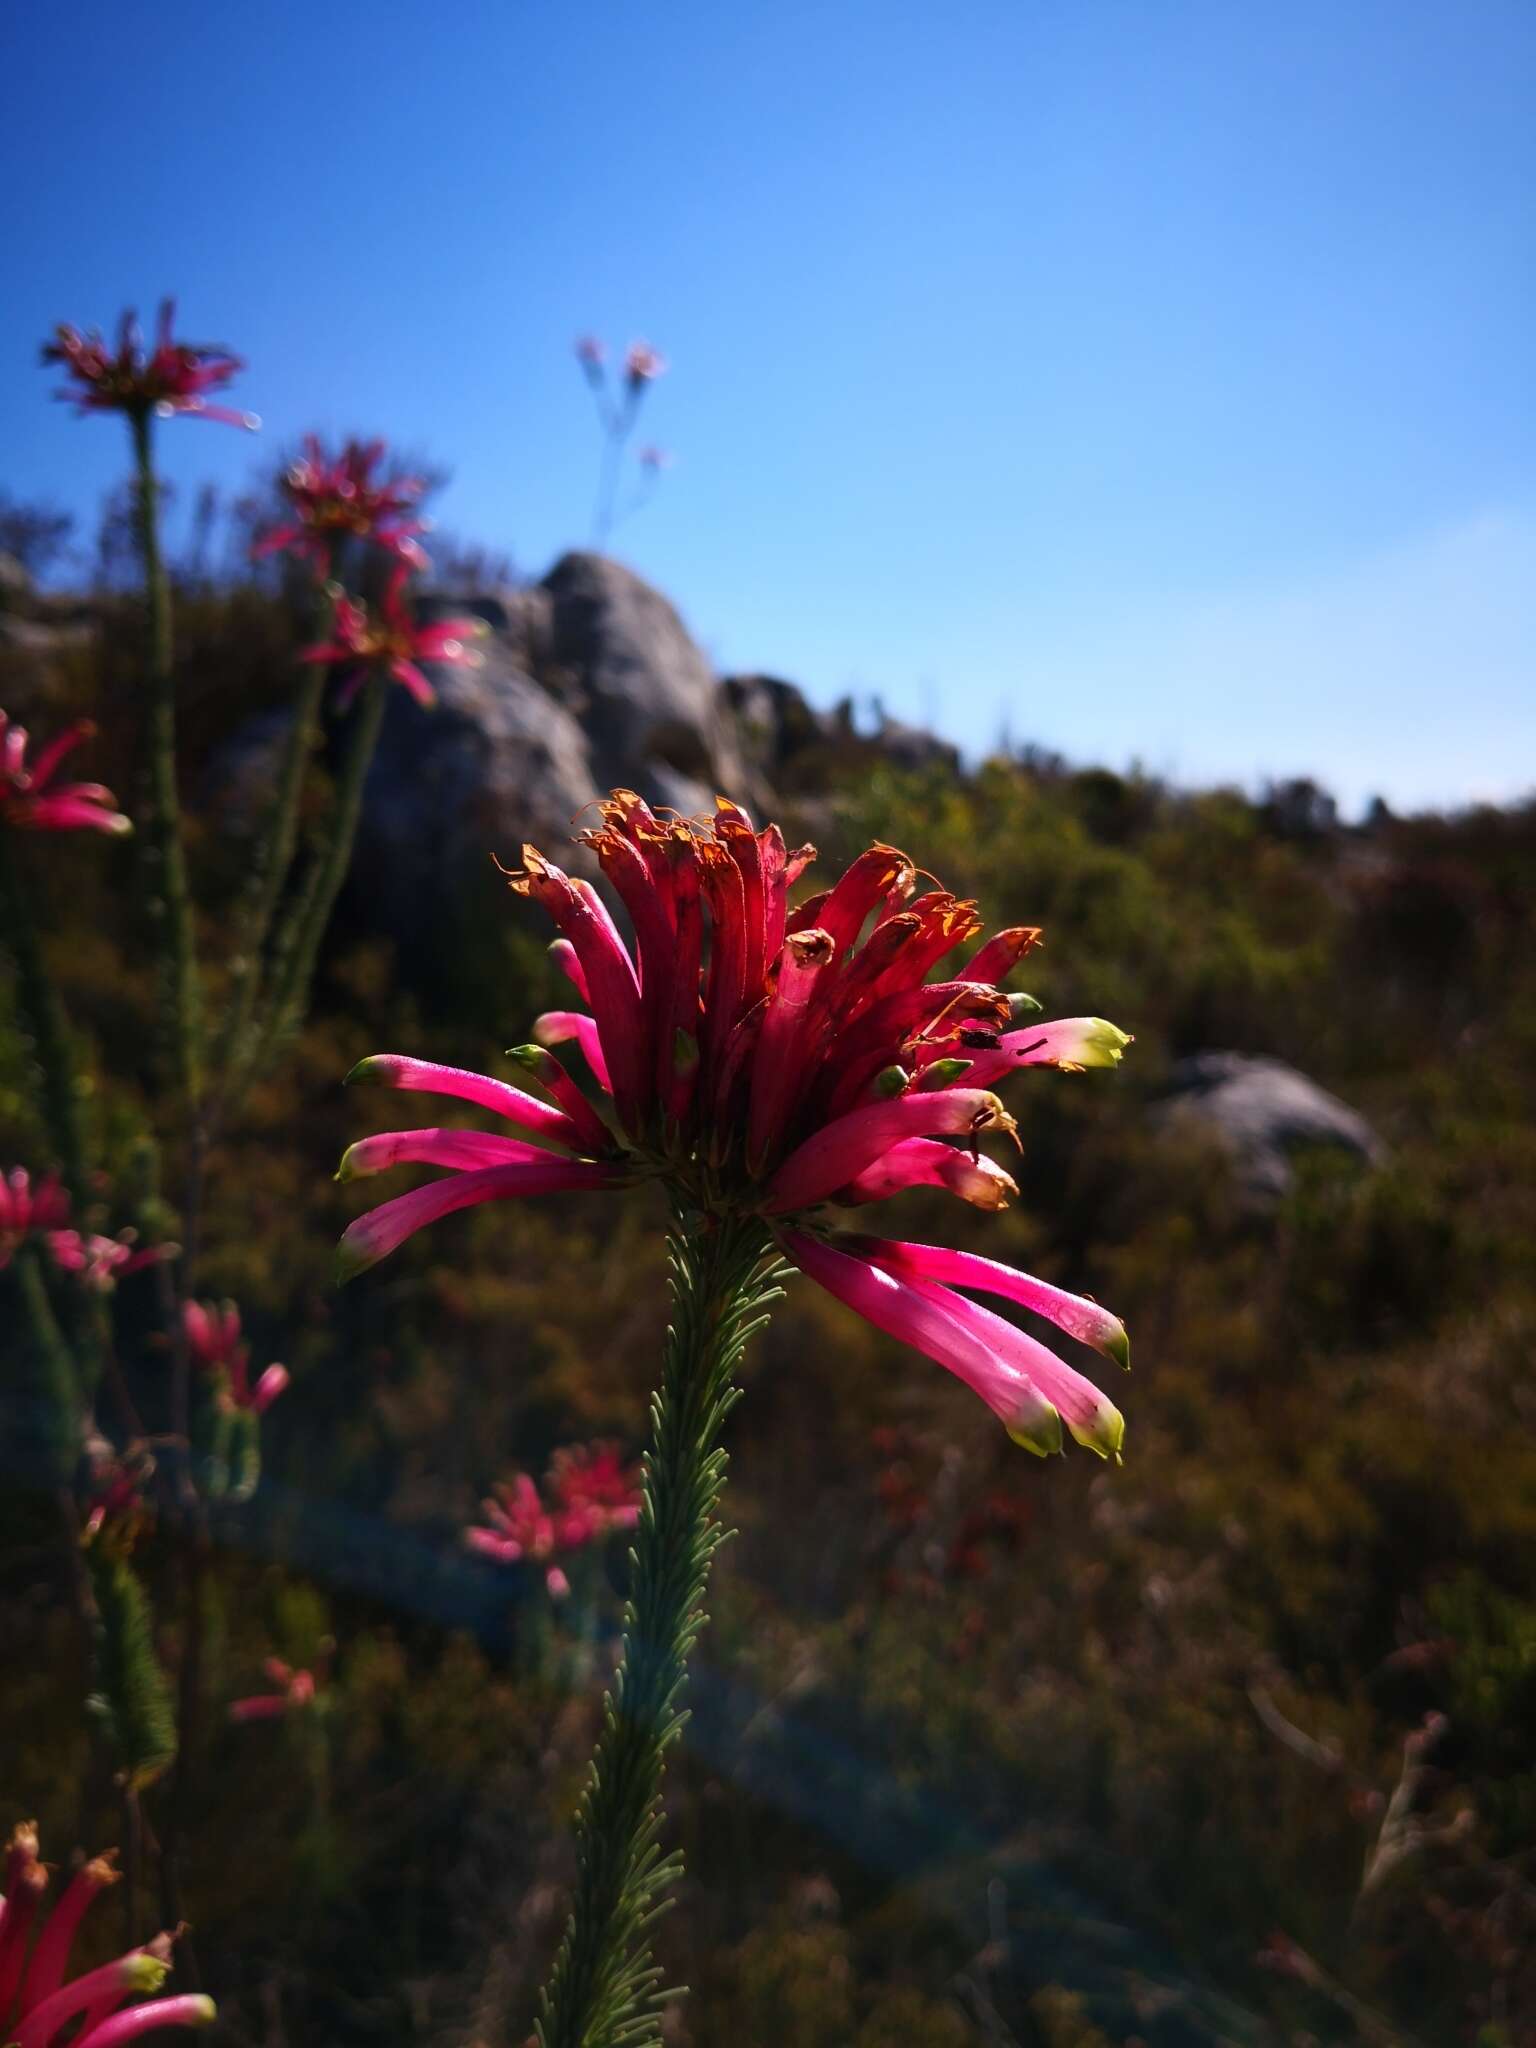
191, 553, 958, 942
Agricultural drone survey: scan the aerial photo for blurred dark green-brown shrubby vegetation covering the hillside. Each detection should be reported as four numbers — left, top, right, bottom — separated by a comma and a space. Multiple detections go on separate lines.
0, 548, 1536, 2048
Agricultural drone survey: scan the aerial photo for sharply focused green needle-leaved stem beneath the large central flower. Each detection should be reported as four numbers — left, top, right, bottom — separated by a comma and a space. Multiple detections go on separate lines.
535, 1212, 780, 2048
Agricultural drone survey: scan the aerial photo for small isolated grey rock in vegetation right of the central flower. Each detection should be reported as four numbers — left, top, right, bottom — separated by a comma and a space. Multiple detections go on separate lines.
1157, 1053, 1384, 1206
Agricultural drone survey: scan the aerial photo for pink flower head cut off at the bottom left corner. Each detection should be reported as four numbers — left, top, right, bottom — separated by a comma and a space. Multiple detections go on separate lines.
0, 1821, 213, 2048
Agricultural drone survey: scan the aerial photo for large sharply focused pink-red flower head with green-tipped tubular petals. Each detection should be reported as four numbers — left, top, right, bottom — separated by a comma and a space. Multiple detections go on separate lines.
340, 791, 1128, 1458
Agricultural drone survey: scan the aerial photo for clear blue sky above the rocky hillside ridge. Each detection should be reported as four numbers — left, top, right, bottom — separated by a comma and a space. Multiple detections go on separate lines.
0, 0, 1536, 805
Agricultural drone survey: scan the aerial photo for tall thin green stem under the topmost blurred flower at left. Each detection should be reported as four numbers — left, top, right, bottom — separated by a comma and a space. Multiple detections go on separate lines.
129, 412, 203, 1110
